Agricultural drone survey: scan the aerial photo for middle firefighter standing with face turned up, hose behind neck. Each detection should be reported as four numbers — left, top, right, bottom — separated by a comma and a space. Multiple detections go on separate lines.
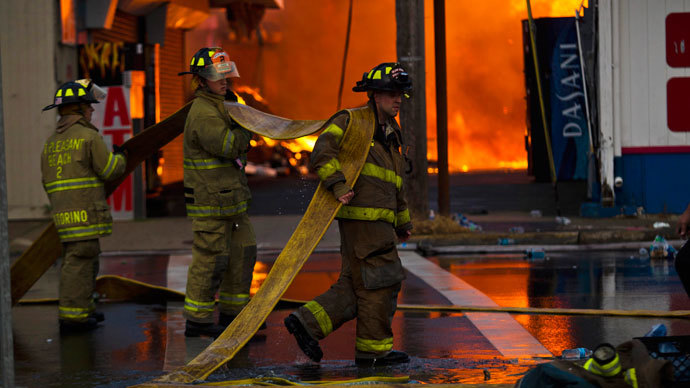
180, 47, 256, 337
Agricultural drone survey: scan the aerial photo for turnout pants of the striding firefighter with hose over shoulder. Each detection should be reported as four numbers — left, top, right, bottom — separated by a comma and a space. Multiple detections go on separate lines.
294, 220, 405, 358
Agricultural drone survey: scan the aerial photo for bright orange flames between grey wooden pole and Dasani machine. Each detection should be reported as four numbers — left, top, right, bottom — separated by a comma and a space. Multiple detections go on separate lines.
425, 0, 587, 172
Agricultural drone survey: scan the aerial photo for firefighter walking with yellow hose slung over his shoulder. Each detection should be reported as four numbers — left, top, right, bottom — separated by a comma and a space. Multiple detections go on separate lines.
285, 63, 412, 366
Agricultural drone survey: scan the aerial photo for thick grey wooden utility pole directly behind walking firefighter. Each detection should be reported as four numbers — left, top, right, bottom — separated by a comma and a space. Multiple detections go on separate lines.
395, 0, 429, 219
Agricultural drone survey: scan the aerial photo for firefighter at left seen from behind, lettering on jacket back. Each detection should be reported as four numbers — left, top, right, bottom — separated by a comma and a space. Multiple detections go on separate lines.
41, 80, 127, 332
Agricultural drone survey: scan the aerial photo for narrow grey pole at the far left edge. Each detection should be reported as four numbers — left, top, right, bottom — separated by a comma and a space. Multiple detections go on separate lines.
0, 44, 14, 388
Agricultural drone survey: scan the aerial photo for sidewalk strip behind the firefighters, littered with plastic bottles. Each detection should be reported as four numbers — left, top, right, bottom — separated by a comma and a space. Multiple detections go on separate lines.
9, 171, 678, 257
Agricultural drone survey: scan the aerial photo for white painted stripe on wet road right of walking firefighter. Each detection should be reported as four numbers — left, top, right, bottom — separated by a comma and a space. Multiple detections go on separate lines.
399, 251, 553, 357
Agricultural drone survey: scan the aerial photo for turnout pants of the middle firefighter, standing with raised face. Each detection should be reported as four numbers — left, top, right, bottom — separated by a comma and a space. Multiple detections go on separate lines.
184, 213, 256, 323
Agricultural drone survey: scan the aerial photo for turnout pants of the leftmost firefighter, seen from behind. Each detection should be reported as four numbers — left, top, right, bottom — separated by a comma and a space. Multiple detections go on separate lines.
58, 239, 101, 321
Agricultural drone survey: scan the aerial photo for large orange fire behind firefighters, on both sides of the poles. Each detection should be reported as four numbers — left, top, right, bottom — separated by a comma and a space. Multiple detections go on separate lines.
187, 0, 587, 172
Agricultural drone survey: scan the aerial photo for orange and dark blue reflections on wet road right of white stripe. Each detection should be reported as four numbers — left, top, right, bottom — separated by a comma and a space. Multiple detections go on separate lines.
430, 252, 690, 354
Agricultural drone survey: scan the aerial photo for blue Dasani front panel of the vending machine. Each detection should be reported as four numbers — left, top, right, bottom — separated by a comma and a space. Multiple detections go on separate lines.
550, 18, 589, 180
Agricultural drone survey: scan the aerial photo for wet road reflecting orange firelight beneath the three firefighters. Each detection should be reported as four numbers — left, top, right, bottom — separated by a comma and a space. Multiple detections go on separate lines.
13, 247, 690, 387
